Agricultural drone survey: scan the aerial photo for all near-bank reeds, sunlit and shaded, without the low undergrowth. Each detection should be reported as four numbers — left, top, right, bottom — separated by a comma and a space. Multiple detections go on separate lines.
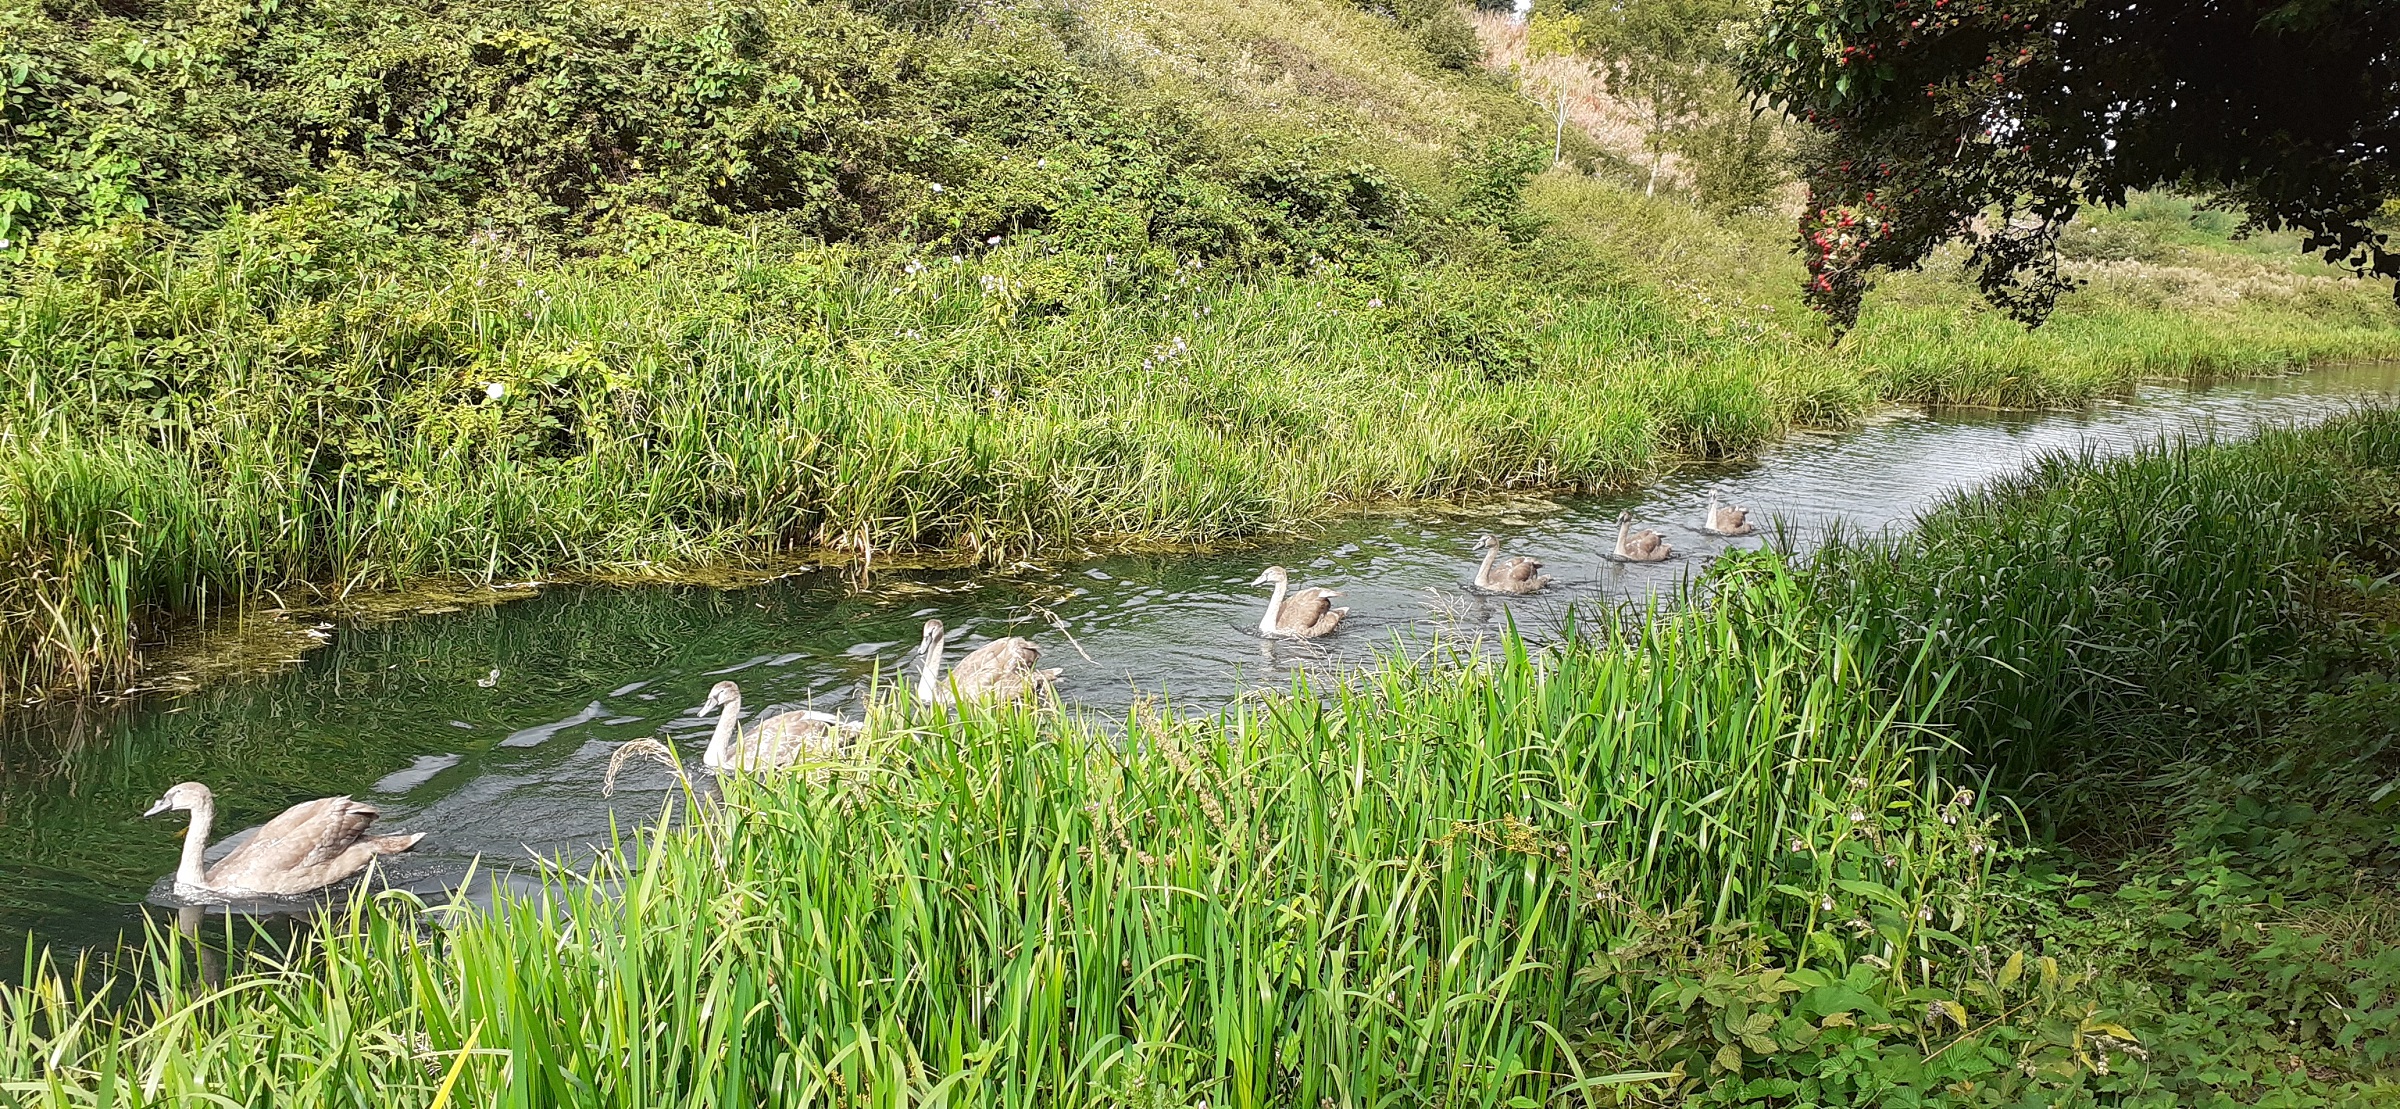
14, 410, 2400, 1107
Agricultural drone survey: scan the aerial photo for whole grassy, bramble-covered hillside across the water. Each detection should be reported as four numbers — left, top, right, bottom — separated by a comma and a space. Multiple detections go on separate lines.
0, 0, 2400, 699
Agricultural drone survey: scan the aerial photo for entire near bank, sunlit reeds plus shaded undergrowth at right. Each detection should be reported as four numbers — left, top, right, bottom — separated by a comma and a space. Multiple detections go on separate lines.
14, 410, 2400, 1104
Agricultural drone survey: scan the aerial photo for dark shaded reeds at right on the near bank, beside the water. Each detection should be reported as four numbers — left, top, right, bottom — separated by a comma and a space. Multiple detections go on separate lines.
1805, 408, 2400, 780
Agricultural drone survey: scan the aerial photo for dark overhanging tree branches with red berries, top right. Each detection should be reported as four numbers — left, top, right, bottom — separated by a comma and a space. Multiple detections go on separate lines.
1745, 0, 2400, 326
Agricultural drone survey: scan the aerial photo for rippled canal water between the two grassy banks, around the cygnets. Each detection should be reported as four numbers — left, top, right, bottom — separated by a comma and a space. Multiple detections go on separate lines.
0, 365, 2400, 948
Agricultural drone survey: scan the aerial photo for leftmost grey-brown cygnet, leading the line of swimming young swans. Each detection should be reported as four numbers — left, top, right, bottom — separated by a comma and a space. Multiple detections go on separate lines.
142, 783, 425, 898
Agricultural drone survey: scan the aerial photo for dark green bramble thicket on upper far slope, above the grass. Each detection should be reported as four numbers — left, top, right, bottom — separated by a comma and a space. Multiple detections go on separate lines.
0, 0, 1409, 264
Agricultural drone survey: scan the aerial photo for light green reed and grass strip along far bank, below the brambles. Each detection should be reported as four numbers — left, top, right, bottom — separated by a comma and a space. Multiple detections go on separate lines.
0, 209, 2388, 699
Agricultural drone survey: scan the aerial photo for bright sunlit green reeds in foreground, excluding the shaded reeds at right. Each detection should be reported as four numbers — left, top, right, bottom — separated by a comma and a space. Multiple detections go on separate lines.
0, 569, 1975, 1107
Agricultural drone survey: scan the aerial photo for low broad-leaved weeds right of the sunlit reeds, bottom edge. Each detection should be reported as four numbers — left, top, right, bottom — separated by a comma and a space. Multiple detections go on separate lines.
1577, 778, 2148, 1104
